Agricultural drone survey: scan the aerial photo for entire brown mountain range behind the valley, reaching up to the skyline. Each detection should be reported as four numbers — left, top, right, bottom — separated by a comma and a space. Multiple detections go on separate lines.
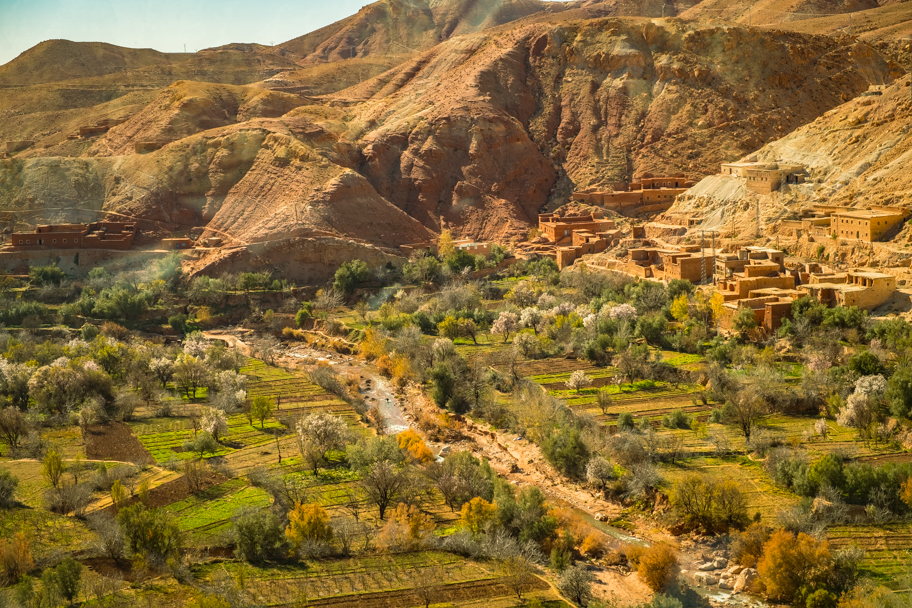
0, 0, 907, 280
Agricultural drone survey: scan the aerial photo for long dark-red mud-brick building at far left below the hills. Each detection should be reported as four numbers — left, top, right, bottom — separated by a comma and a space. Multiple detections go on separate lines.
10, 222, 138, 250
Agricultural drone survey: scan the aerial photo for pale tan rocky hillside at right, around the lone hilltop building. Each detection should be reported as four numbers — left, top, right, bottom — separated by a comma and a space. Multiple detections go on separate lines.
667, 66, 912, 233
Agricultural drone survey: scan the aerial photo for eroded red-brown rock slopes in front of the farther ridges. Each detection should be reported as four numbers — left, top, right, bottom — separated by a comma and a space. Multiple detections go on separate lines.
0, 5, 899, 254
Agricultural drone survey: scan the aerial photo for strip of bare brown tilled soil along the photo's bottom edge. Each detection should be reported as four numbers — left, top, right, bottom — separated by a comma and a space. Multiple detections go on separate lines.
281, 578, 550, 608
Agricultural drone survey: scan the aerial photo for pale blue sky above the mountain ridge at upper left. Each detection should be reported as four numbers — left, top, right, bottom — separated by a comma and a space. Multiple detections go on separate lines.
0, 0, 373, 65
